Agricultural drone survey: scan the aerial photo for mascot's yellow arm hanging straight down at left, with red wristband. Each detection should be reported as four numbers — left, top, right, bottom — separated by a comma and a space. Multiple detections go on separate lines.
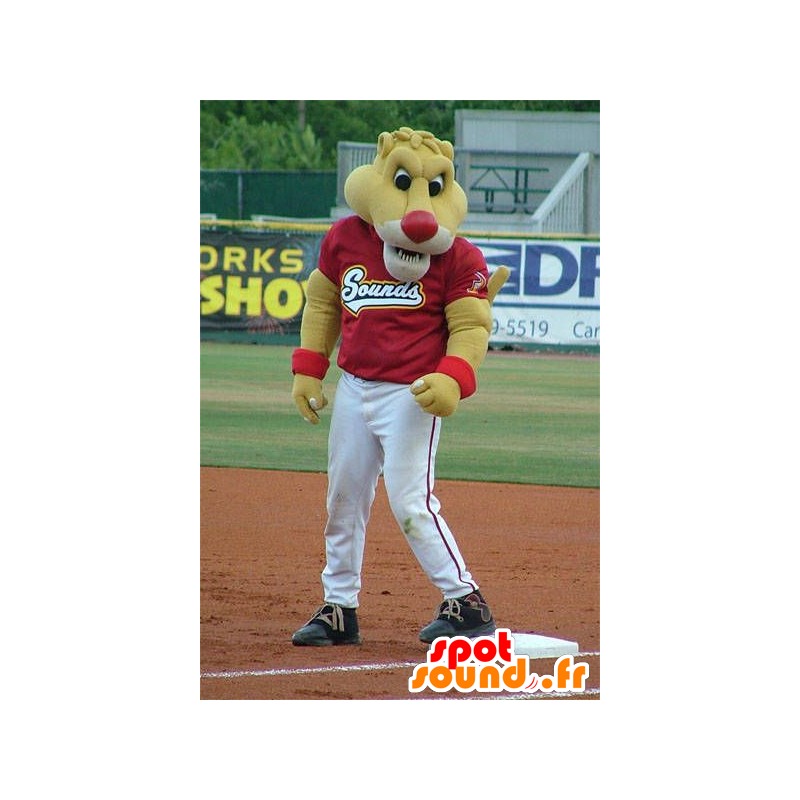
292, 269, 342, 425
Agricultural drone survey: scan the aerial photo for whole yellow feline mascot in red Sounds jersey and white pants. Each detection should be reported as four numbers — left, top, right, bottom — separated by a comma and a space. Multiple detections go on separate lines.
292, 128, 508, 646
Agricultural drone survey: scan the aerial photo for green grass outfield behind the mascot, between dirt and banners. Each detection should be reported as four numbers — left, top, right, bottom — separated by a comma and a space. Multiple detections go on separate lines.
200, 342, 600, 487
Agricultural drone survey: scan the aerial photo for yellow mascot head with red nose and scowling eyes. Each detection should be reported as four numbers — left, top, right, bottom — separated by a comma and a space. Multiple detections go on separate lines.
344, 128, 467, 281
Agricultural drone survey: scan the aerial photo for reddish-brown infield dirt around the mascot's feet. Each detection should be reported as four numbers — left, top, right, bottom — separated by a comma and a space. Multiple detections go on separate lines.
200, 467, 600, 700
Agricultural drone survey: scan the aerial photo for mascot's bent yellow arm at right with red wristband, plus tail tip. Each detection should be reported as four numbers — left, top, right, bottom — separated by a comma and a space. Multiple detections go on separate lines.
411, 267, 509, 417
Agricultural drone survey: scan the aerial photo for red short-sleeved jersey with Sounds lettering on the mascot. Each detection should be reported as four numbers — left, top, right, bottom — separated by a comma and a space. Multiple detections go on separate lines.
319, 216, 489, 383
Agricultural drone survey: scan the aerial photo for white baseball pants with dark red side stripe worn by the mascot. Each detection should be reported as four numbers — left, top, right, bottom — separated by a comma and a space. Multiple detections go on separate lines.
322, 372, 478, 608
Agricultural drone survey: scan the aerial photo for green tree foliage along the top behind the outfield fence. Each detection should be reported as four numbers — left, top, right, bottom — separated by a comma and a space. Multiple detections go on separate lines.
200, 100, 600, 170
